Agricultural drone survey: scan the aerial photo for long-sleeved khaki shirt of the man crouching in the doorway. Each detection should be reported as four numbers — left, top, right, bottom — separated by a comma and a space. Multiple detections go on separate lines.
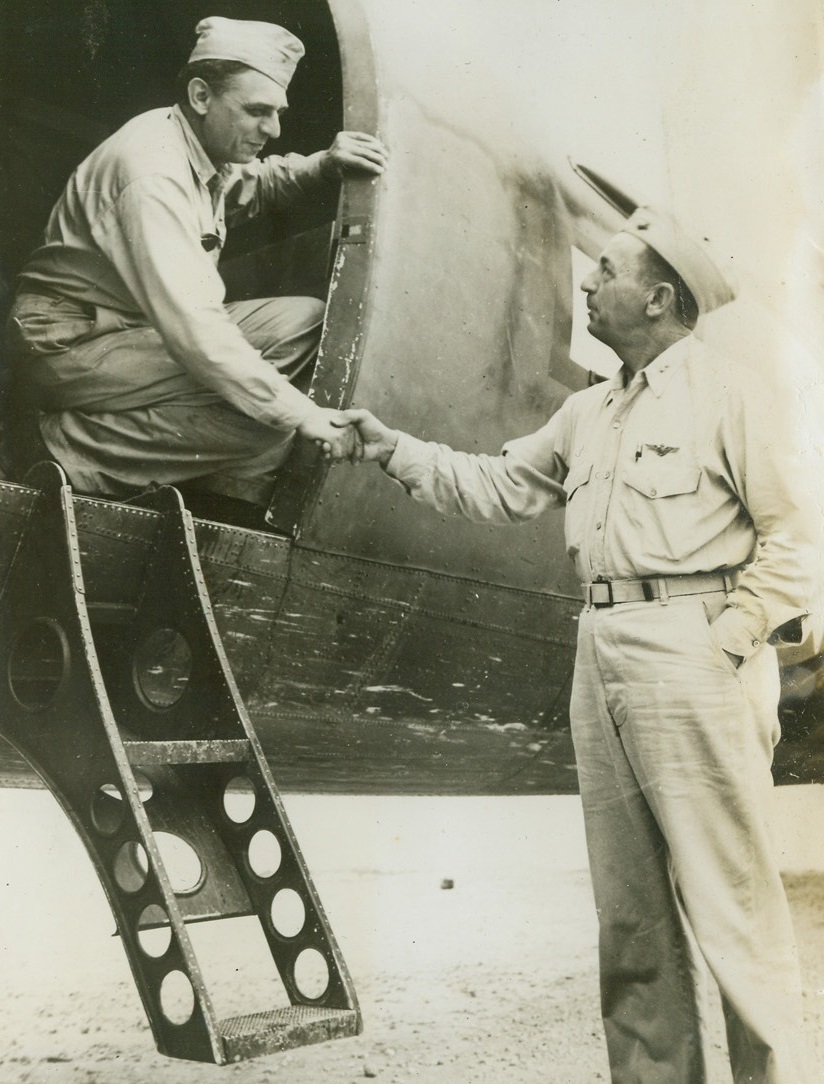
20, 106, 321, 427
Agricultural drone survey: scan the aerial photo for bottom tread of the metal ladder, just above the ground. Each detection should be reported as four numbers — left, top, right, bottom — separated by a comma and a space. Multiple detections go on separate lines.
218, 1005, 360, 1061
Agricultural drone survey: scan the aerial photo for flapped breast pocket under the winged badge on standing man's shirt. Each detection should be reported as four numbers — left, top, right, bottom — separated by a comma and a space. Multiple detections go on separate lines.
618, 457, 706, 562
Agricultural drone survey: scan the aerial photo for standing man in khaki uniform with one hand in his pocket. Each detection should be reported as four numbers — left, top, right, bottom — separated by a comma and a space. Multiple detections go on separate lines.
336, 208, 821, 1084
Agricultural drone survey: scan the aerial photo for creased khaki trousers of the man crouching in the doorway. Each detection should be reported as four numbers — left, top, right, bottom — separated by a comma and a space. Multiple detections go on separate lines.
9, 294, 324, 504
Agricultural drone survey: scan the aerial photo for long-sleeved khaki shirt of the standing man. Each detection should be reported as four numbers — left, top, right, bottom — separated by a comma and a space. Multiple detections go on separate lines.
387, 336, 820, 658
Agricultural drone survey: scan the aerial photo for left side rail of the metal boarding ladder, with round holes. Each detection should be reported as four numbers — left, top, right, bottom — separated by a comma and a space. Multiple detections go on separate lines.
0, 464, 222, 1060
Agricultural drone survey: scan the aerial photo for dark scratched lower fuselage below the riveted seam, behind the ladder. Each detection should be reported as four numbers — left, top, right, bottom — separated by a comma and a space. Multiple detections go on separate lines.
0, 483, 575, 792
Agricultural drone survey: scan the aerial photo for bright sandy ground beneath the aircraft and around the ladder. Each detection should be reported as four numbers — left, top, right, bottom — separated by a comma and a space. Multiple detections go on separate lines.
0, 788, 824, 1084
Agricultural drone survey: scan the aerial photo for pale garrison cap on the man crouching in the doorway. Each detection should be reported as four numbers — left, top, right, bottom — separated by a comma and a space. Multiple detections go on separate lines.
189, 15, 306, 90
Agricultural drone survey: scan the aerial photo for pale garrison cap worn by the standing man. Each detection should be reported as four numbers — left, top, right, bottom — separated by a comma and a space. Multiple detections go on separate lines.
620, 207, 736, 313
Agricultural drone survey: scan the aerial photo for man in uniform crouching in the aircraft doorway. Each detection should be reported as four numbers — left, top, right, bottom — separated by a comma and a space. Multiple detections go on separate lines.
9, 17, 386, 515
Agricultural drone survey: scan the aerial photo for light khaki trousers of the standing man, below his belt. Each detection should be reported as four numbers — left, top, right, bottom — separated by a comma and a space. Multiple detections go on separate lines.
571, 592, 807, 1084
